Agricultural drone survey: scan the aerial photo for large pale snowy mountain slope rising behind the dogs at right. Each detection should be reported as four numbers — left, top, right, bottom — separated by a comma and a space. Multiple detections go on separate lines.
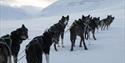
41, 0, 123, 16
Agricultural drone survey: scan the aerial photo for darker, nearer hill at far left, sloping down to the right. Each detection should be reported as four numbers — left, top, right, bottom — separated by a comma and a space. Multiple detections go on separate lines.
0, 5, 27, 20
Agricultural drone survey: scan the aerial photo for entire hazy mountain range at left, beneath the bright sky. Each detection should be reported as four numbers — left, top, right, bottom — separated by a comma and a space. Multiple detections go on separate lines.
0, 5, 42, 20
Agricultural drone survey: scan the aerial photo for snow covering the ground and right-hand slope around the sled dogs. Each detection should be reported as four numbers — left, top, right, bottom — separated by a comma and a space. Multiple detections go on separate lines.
0, 0, 125, 63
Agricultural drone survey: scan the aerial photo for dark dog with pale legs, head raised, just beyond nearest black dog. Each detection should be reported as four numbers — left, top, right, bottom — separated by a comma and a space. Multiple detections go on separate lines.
50, 15, 69, 51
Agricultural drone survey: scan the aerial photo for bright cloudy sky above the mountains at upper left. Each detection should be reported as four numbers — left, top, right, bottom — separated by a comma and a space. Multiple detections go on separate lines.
0, 0, 57, 8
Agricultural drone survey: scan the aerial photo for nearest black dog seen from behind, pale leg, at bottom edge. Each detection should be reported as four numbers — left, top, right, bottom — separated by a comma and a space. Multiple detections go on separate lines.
25, 30, 56, 63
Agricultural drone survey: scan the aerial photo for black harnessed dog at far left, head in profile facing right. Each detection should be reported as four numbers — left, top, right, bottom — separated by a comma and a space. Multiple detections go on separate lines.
0, 25, 28, 63
